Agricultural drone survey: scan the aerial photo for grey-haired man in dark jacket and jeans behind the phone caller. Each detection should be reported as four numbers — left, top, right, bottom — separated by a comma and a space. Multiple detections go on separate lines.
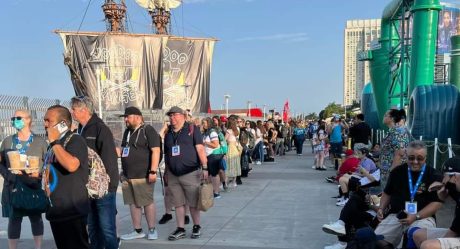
71, 96, 119, 249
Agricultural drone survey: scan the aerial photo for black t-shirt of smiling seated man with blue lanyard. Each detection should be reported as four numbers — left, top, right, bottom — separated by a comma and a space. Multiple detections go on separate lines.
384, 164, 442, 214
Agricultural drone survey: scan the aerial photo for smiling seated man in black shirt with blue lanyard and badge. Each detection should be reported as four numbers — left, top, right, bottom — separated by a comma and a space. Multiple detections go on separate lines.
375, 141, 442, 248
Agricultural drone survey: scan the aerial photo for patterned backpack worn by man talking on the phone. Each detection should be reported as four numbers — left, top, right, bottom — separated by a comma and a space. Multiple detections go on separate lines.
64, 133, 110, 199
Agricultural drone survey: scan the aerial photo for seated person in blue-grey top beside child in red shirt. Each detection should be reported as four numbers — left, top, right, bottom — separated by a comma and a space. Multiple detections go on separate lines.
337, 147, 380, 206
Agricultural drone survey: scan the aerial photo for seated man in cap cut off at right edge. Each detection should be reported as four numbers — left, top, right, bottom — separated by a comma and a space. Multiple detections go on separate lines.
413, 157, 460, 249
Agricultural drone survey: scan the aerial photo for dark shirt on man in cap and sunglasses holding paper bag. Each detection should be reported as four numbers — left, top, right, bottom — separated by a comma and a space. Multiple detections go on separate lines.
164, 123, 203, 176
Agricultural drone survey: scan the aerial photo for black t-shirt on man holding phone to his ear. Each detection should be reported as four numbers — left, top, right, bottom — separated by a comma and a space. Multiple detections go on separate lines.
46, 132, 89, 221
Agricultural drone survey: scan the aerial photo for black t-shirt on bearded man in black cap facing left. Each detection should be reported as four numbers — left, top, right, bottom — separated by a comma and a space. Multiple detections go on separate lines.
121, 125, 161, 179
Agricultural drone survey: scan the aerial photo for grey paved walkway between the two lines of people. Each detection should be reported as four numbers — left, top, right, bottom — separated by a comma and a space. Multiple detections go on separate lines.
0, 146, 452, 249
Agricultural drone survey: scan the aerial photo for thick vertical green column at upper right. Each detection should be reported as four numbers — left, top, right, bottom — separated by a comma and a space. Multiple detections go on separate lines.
408, 0, 441, 97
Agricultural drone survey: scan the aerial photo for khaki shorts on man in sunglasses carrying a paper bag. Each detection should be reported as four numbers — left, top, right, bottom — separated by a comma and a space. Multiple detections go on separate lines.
168, 170, 201, 208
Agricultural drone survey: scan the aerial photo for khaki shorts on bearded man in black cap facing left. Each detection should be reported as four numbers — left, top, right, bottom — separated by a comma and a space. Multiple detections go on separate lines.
121, 178, 155, 207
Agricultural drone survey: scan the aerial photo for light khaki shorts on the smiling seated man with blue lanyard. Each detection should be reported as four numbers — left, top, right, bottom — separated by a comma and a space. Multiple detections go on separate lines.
375, 214, 436, 248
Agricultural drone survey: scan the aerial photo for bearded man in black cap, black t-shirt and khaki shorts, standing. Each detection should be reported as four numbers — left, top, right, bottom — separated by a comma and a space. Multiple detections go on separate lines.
120, 106, 161, 240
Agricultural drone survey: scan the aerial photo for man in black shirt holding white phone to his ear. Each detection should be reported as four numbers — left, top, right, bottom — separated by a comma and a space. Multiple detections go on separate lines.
43, 105, 89, 249
